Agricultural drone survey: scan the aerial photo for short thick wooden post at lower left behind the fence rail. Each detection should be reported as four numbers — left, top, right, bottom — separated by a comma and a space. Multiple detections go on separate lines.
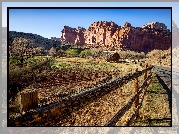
21, 89, 38, 113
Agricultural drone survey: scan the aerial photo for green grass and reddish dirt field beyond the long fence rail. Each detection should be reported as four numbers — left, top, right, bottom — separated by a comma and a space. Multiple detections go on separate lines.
10, 57, 141, 117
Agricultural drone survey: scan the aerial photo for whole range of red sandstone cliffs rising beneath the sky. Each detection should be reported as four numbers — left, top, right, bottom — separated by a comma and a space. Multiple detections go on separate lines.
61, 21, 171, 52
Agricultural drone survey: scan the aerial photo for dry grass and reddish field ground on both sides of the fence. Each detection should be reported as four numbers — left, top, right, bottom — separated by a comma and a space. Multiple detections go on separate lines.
10, 56, 171, 126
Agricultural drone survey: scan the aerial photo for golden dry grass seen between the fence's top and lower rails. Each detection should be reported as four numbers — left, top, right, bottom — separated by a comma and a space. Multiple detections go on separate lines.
50, 68, 148, 126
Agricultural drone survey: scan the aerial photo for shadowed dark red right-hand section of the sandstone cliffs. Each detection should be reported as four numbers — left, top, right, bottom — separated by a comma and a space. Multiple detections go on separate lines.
119, 22, 171, 52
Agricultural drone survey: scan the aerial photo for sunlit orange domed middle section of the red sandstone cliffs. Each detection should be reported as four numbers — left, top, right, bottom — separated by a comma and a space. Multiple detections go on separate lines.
84, 21, 120, 47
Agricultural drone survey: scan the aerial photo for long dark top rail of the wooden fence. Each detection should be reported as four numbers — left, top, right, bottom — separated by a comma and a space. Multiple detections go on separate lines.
10, 66, 153, 126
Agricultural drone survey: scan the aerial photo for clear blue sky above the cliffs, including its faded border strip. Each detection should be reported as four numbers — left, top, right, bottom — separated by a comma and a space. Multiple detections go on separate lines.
2, 2, 179, 38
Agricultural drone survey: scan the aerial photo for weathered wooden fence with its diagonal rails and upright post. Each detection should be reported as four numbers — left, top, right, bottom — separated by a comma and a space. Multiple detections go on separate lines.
10, 63, 153, 126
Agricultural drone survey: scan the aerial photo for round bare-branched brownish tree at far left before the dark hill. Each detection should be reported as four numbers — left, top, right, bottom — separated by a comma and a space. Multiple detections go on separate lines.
9, 37, 37, 64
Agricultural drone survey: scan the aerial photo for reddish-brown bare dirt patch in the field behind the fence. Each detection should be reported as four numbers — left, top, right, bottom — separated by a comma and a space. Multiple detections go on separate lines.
31, 71, 113, 103
